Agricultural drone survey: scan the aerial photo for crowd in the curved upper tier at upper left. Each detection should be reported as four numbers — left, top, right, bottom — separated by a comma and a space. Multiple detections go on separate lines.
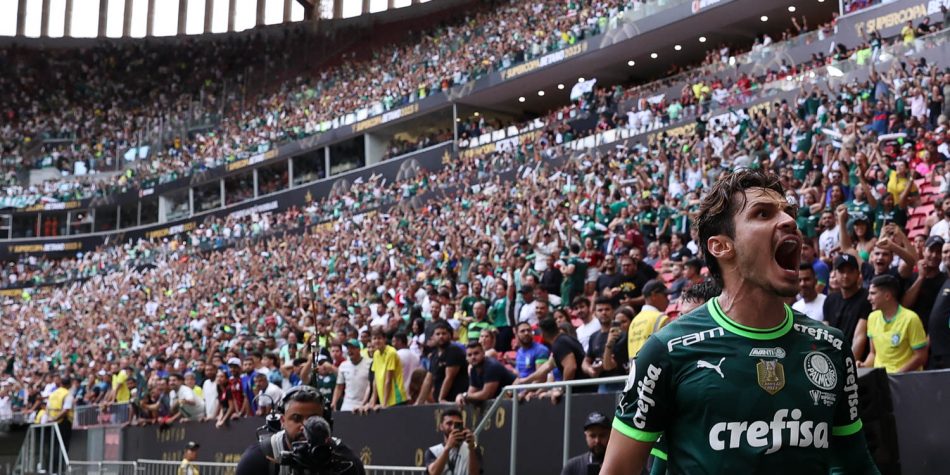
0, 0, 668, 209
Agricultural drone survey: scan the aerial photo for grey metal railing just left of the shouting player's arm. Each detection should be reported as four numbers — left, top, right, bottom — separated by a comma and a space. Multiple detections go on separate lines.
475, 376, 627, 475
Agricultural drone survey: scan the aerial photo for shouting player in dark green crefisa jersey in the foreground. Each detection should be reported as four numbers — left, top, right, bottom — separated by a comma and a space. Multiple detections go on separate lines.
601, 170, 879, 475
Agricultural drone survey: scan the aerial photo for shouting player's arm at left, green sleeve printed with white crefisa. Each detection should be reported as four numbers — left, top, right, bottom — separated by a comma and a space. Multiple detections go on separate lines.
600, 336, 674, 475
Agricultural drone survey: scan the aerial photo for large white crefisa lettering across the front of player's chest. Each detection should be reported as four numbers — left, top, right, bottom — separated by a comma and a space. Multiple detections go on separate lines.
709, 409, 828, 454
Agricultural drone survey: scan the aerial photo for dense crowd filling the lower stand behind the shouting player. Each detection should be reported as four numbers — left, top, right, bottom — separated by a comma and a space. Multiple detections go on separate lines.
0, 3, 950, 448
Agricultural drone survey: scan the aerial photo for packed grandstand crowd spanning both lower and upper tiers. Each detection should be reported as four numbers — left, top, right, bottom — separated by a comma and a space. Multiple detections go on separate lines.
0, 0, 950, 472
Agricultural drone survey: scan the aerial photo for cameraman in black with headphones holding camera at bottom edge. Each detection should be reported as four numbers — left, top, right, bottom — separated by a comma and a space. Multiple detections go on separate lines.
236, 386, 366, 475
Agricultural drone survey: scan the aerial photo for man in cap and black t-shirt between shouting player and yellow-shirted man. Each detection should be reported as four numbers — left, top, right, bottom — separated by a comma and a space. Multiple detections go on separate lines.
822, 254, 871, 361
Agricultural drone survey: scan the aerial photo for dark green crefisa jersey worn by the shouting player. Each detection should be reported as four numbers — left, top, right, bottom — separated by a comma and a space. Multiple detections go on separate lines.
613, 298, 866, 475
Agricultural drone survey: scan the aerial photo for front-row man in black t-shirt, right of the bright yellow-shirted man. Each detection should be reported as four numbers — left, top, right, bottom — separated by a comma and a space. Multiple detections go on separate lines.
418, 322, 468, 404
